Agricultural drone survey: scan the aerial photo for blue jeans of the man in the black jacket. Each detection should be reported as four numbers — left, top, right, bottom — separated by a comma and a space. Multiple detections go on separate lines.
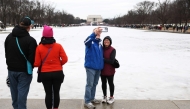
8, 70, 32, 109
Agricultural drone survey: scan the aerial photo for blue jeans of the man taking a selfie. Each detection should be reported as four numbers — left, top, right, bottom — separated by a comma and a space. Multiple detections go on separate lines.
84, 68, 101, 103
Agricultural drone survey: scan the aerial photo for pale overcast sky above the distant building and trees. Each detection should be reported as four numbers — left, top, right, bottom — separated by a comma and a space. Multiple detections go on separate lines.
45, 0, 169, 19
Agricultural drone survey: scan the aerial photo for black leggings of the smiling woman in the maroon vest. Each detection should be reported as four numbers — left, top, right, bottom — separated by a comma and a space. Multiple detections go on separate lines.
101, 75, 114, 97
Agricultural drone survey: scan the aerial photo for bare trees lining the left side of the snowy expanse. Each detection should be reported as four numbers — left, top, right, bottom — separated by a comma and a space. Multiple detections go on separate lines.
0, 0, 85, 25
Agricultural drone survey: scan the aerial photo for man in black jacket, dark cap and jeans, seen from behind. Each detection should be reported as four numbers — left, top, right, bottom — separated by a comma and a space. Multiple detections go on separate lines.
4, 17, 37, 109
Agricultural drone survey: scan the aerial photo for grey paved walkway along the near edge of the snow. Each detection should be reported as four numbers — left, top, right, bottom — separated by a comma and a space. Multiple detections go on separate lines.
0, 99, 190, 109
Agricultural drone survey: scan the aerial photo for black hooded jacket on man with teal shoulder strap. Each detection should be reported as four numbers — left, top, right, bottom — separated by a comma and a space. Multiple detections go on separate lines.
4, 26, 37, 72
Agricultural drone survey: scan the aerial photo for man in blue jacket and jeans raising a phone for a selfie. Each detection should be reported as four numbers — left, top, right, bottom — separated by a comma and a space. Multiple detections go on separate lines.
84, 28, 104, 109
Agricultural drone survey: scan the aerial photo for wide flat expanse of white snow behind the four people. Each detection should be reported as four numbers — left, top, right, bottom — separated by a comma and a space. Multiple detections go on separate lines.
0, 26, 190, 100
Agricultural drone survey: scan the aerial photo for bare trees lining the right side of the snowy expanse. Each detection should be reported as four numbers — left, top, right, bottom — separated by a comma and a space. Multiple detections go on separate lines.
104, 0, 190, 26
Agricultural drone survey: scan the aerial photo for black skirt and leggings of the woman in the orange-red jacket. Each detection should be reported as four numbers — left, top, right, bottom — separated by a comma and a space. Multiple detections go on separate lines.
41, 71, 64, 109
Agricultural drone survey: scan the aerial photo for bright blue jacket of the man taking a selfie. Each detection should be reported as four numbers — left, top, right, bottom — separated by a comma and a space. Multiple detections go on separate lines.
84, 33, 104, 70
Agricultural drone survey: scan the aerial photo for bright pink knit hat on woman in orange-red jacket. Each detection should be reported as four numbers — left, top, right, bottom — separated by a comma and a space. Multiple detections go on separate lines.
42, 25, 53, 37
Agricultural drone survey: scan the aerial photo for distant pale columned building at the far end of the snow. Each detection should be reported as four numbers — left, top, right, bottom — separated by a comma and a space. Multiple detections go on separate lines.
86, 15, 103, 25
